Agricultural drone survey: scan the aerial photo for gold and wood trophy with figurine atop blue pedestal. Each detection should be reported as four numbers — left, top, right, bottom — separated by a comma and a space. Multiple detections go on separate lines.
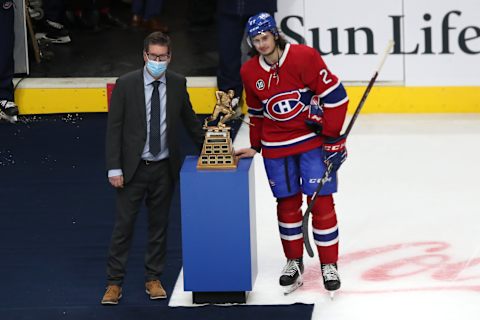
197, 90, 238, 170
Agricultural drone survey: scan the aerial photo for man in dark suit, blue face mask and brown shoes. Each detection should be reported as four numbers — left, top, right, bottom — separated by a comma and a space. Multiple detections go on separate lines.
101, 32, 203, 304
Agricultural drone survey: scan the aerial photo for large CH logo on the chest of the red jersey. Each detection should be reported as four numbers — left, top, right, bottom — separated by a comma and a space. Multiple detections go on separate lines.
265, 91, 305, 121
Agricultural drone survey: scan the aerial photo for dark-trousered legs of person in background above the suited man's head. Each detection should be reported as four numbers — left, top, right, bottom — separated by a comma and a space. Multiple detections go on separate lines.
131, 0, 168, 32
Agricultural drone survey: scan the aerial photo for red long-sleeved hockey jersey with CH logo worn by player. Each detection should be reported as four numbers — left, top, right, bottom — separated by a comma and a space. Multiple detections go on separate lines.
240, 44, 348, 158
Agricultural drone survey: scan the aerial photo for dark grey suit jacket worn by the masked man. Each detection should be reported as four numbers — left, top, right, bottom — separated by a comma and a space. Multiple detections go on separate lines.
106, 68, 204, 184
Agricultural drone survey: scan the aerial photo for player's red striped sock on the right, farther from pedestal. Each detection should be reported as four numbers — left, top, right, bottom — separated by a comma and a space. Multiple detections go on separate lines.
307, 195, 338, 263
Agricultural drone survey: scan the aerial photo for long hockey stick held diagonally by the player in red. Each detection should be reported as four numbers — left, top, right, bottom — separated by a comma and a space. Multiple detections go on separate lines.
302, 40, 394, 257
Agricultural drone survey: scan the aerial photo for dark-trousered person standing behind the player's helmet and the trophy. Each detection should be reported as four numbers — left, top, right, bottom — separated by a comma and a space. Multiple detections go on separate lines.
217, 0, 277, 116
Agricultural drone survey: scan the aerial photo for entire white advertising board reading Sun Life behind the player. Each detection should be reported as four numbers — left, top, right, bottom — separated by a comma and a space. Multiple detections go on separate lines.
275, 0, 480, 86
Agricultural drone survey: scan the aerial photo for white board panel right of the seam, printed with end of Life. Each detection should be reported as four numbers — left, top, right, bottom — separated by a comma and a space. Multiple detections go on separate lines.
404, 0, 480, 86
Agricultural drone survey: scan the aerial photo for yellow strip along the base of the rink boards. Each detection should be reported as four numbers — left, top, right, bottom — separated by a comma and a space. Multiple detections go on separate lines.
11, 77, 480, 115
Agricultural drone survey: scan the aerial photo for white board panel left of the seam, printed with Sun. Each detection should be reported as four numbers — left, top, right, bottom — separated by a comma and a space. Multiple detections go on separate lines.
276, 0, 404, 82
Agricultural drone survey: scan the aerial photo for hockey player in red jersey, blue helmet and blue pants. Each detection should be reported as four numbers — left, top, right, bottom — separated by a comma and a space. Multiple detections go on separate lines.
236, 13, 348, 294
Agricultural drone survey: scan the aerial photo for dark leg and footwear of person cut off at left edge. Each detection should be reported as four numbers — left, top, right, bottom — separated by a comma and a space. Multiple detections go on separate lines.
0, 0, 18, 121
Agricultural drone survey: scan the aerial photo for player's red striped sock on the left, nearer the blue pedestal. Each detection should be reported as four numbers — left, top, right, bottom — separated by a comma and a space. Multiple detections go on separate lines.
277, 193, 303, 259
